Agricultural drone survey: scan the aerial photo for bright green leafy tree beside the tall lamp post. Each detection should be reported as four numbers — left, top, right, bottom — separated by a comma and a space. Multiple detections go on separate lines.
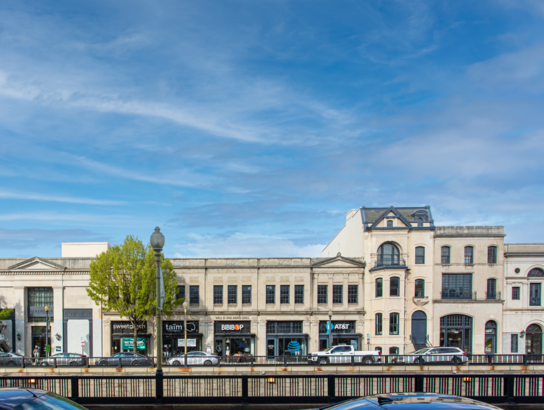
87, 235, 183, 355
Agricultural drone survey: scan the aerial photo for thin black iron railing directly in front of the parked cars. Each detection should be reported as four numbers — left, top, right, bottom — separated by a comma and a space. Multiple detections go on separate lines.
0, 354, 544, 368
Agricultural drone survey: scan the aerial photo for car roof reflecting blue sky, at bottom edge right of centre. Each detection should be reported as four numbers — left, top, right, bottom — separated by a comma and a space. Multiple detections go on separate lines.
319, 393, 500, 410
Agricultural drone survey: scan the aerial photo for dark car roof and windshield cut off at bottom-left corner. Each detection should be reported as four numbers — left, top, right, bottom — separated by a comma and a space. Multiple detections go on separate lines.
0, 387, 87, 410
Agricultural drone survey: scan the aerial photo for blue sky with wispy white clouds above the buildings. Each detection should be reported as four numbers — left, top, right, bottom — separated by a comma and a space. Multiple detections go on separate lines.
0, 0, 544, 257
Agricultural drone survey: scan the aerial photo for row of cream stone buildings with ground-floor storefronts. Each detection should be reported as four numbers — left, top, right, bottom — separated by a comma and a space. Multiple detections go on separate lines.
0, 207, 544, 357
